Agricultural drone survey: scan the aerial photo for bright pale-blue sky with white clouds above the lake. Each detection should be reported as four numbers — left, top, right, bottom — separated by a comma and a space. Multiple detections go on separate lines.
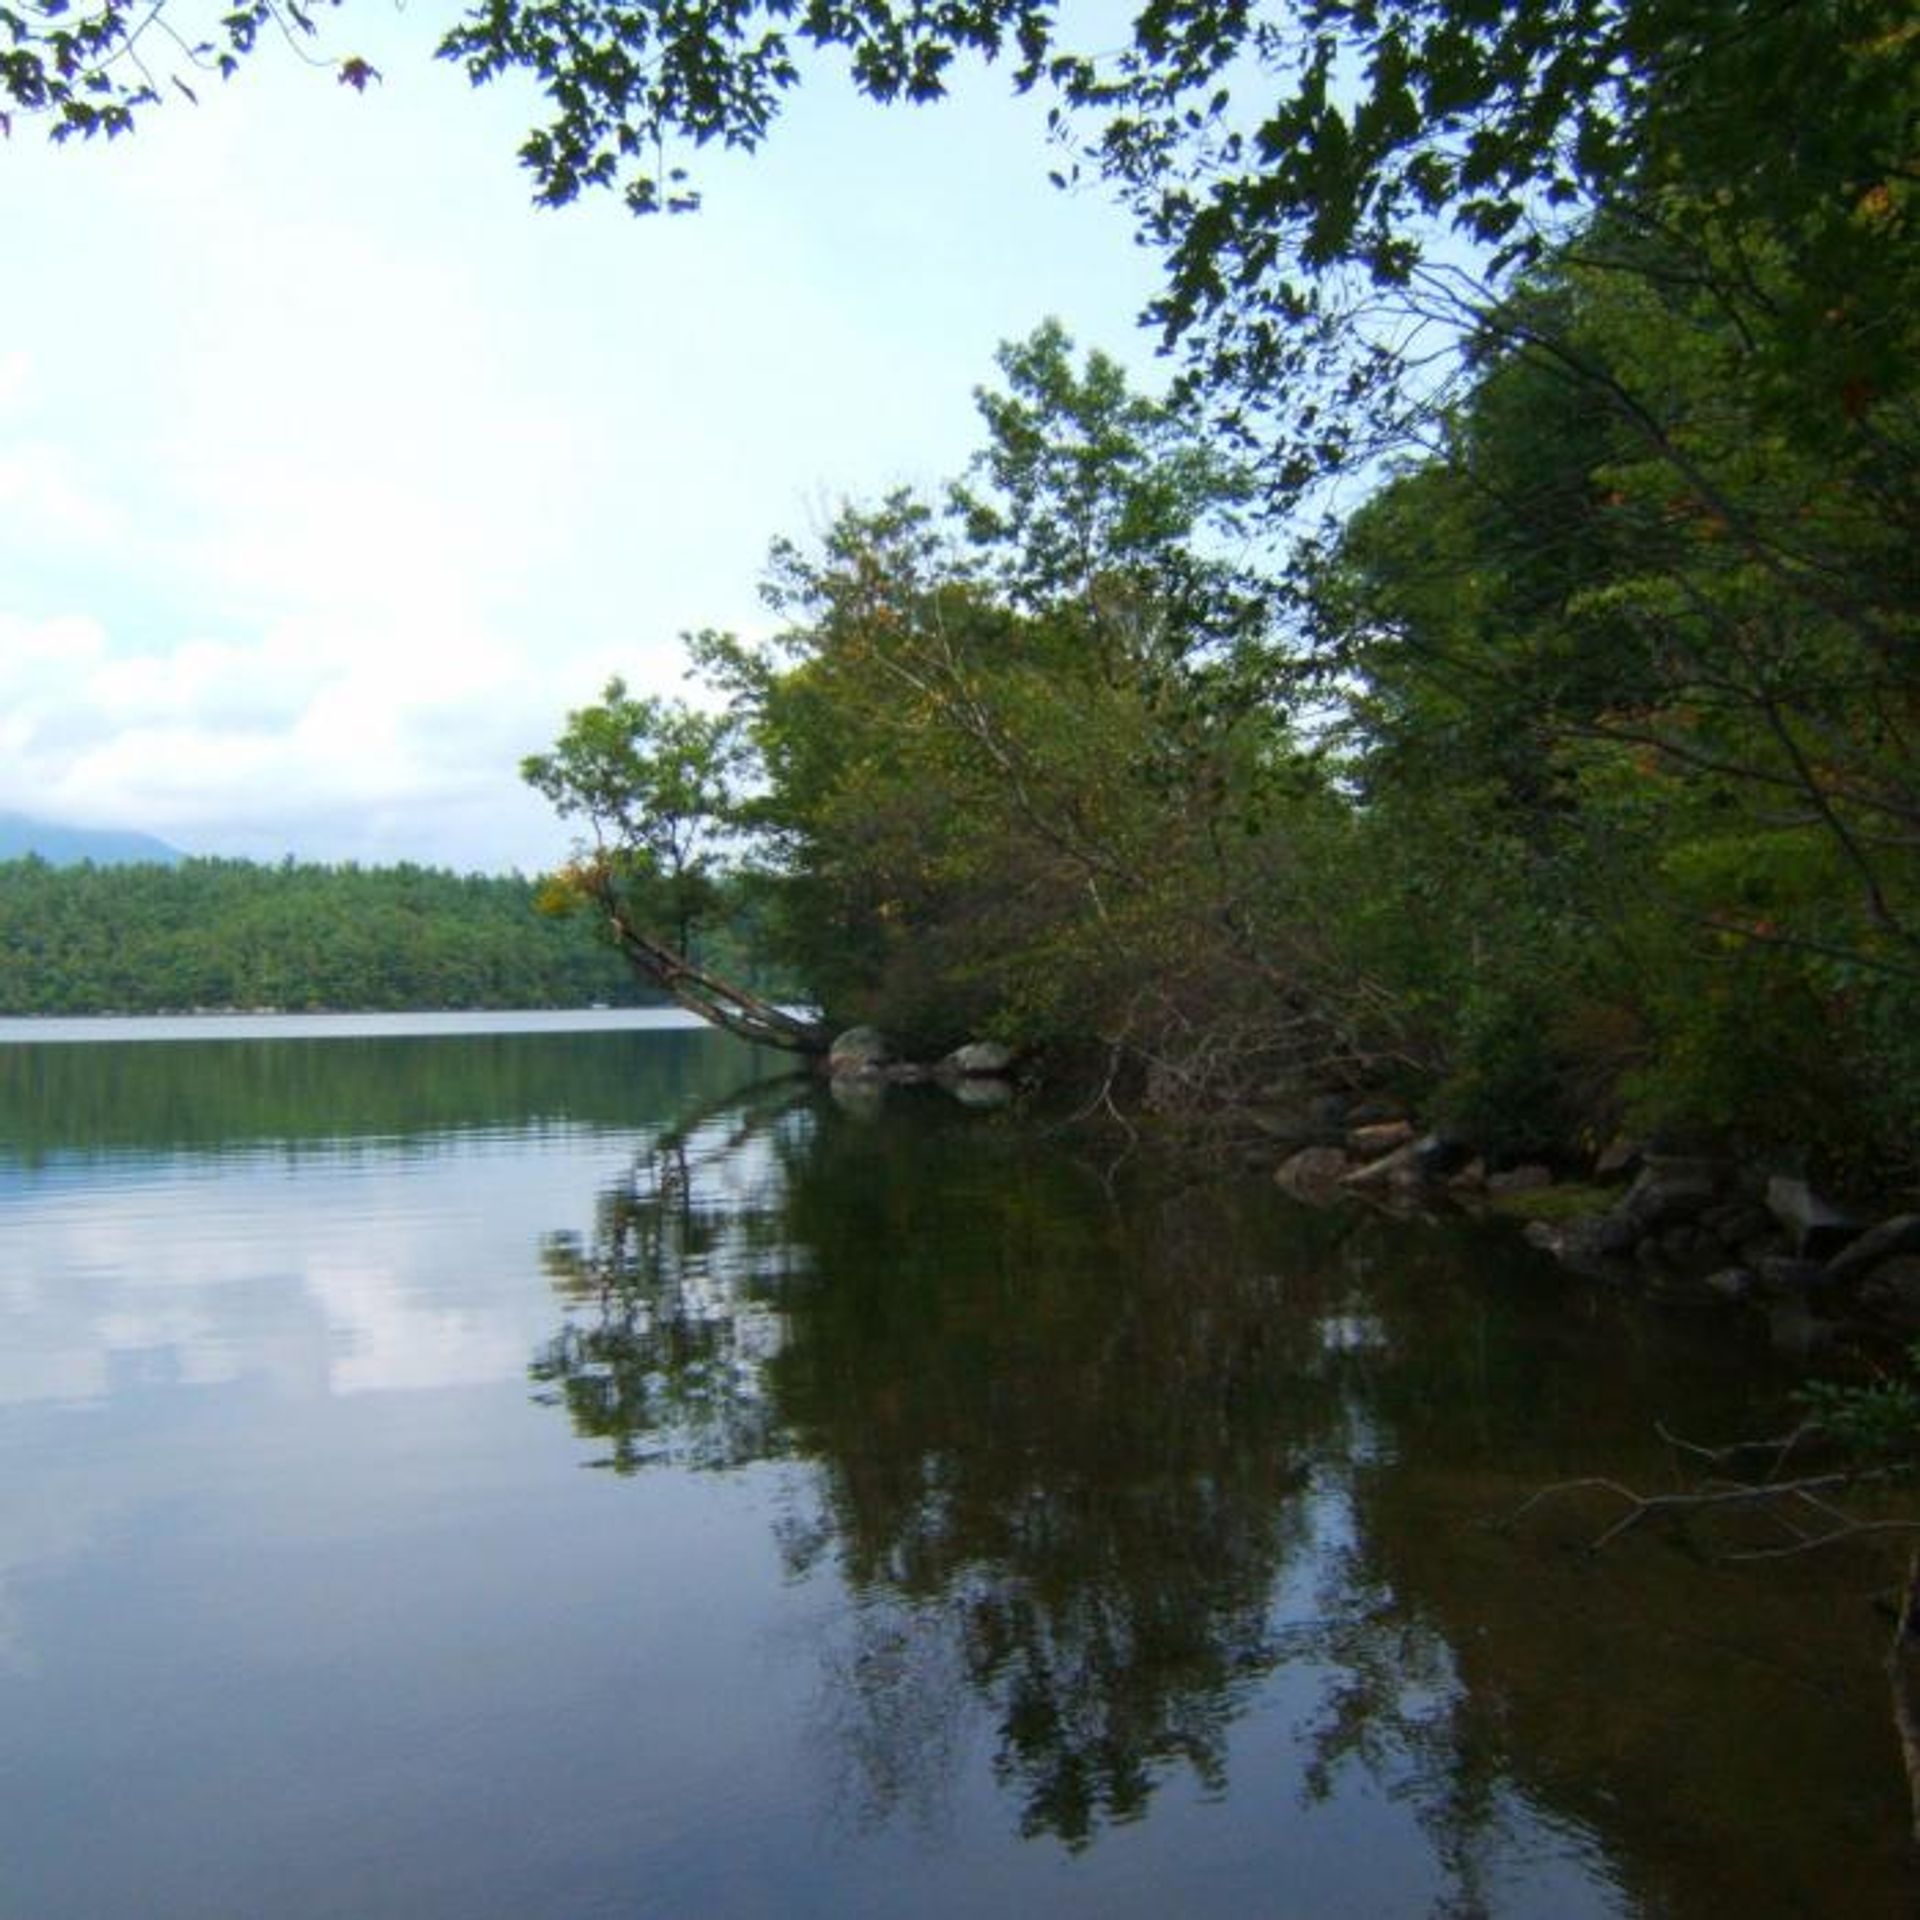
0, 4, 1160, 872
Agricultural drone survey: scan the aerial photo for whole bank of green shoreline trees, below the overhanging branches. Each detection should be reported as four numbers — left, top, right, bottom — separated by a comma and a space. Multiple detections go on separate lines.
530, 253, 1920, 1175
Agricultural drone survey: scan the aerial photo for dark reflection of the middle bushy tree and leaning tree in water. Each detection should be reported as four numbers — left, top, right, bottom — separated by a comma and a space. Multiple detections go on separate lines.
532, 1094, 1323, 1845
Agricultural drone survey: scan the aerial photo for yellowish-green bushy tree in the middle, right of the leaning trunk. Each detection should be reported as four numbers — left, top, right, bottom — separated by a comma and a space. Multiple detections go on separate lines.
683, 324, 1390, 1110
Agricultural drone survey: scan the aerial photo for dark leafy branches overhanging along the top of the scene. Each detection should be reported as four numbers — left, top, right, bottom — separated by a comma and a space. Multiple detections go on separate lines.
26, 0, 1916, 414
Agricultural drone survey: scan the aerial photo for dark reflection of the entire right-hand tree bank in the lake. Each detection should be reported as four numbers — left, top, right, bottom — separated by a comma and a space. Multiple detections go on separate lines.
532, 1094, 1905, 1914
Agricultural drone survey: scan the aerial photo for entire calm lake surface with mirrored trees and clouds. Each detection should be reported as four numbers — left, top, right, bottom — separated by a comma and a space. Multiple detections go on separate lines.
0, 1016, 1912, 1920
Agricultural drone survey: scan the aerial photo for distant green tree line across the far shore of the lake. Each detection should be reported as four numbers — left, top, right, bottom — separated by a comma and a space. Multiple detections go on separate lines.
0, 858, 783, 1014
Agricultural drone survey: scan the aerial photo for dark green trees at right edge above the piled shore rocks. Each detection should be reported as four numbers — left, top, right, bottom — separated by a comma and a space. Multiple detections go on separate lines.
1315, 230, 1920, 1171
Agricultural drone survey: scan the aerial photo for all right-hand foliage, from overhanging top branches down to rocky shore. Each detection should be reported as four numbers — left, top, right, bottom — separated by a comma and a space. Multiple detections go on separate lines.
514, 0, 1920, 1175
